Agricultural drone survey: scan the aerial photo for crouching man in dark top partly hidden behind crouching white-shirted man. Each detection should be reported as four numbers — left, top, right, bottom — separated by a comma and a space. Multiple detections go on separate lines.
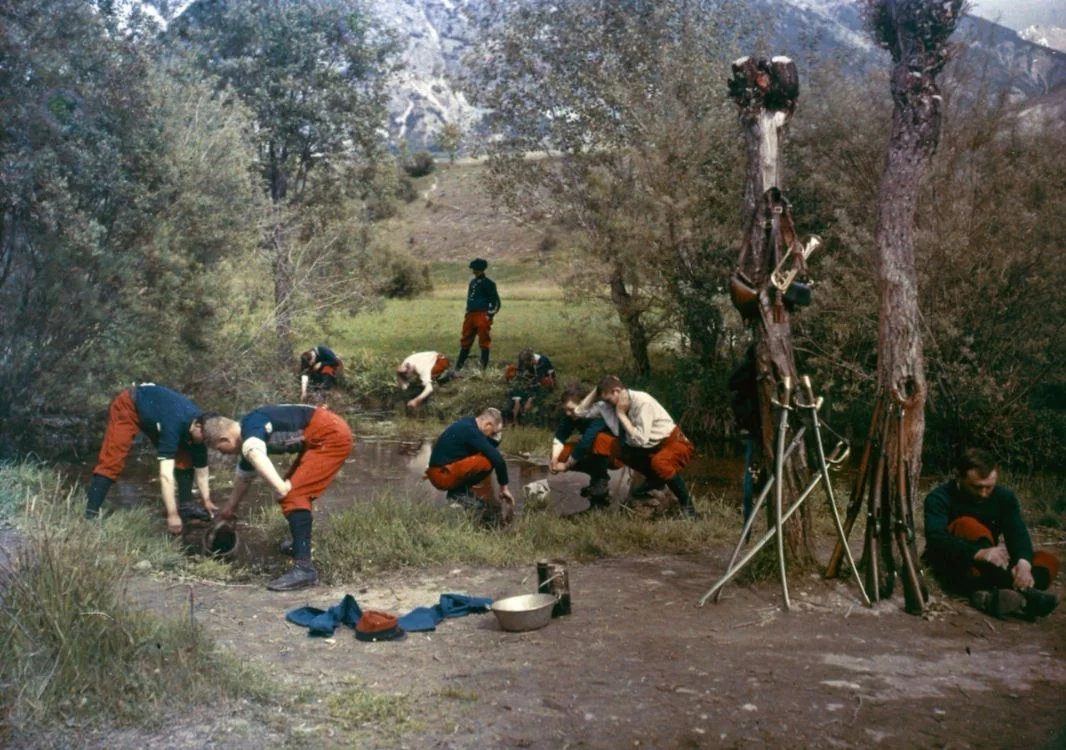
551, 385, 621, 509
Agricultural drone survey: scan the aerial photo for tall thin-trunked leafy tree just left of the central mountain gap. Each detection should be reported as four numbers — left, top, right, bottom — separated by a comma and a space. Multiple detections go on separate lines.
169, 0, 397, 362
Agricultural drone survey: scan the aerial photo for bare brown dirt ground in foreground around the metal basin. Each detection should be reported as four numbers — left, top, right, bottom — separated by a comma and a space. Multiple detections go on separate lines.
62, 550, 1066, 749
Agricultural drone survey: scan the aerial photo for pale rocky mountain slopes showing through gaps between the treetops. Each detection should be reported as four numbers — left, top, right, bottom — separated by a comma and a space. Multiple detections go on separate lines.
137, 0, 1066, 149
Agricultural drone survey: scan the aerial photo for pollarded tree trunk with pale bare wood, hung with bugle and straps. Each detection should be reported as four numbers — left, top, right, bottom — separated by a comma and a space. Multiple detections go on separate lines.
729, 58, 814, 565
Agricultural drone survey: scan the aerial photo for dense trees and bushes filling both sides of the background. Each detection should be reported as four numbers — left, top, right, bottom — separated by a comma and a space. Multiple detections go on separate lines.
0, 0, 1066, 470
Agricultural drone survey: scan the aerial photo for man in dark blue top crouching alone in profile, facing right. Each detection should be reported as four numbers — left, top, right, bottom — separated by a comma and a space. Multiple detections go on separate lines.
425, 408, 515, 521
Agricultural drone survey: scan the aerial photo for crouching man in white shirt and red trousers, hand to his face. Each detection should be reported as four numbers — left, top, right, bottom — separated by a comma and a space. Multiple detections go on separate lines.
599, 375, 696, 519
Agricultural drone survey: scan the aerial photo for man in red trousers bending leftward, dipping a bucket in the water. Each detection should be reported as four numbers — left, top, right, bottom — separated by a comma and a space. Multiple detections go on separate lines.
203, 404, 352, 591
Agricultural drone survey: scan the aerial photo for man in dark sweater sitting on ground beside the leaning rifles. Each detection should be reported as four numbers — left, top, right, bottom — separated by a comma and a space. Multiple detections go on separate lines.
925, 447, 1059, 617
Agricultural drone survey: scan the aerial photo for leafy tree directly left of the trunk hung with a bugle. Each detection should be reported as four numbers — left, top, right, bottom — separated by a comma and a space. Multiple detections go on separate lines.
467, 0, 743, 374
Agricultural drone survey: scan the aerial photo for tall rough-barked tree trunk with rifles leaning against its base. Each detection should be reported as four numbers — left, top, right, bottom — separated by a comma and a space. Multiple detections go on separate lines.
830, 0, 964, 614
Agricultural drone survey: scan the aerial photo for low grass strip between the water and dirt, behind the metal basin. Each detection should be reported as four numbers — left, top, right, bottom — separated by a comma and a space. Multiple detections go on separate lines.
316, 494, 736, 583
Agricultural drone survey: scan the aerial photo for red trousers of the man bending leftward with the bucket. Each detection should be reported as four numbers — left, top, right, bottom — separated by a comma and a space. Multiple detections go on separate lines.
280, 408, 352, 516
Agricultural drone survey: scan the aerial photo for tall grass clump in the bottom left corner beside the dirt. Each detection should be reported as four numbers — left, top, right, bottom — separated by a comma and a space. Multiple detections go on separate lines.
0, 467, 263, 738
